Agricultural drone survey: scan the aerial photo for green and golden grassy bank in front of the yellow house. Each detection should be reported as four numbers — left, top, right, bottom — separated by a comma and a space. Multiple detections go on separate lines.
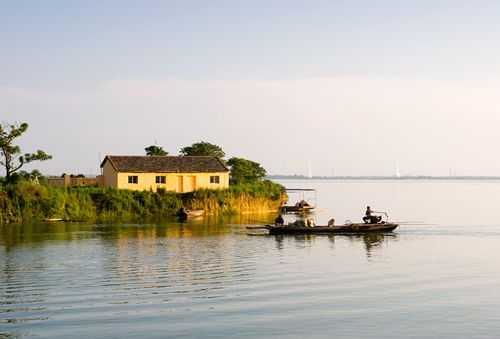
0, 180, 283, 224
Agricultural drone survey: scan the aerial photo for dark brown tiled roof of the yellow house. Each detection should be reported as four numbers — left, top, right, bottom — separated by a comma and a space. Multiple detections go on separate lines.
101, 155, 229, 173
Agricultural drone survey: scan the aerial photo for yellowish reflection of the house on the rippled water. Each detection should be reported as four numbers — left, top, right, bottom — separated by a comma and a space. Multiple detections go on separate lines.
100, 223, 258, 293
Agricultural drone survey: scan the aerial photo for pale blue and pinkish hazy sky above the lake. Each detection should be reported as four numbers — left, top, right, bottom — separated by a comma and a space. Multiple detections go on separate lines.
0, 0, 500, 175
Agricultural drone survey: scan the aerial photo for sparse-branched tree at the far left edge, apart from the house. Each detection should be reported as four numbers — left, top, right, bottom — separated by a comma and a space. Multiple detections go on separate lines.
0, 122, 52, 182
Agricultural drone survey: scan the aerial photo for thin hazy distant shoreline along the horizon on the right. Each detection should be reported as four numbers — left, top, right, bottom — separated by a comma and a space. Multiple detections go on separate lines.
266, 175, 500, 181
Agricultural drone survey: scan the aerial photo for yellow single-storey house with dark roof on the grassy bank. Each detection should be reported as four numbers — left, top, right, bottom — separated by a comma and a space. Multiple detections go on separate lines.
100, 155, 229, 193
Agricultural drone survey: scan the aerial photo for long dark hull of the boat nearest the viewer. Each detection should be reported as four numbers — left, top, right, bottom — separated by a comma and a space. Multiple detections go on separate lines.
247, 223, 399, 235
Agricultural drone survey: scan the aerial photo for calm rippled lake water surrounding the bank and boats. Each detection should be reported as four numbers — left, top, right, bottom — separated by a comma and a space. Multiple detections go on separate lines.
0, 180, 500, 338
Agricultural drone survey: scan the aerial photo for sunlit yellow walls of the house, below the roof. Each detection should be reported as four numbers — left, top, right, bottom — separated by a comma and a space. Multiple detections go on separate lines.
103, 169, 229, 193
